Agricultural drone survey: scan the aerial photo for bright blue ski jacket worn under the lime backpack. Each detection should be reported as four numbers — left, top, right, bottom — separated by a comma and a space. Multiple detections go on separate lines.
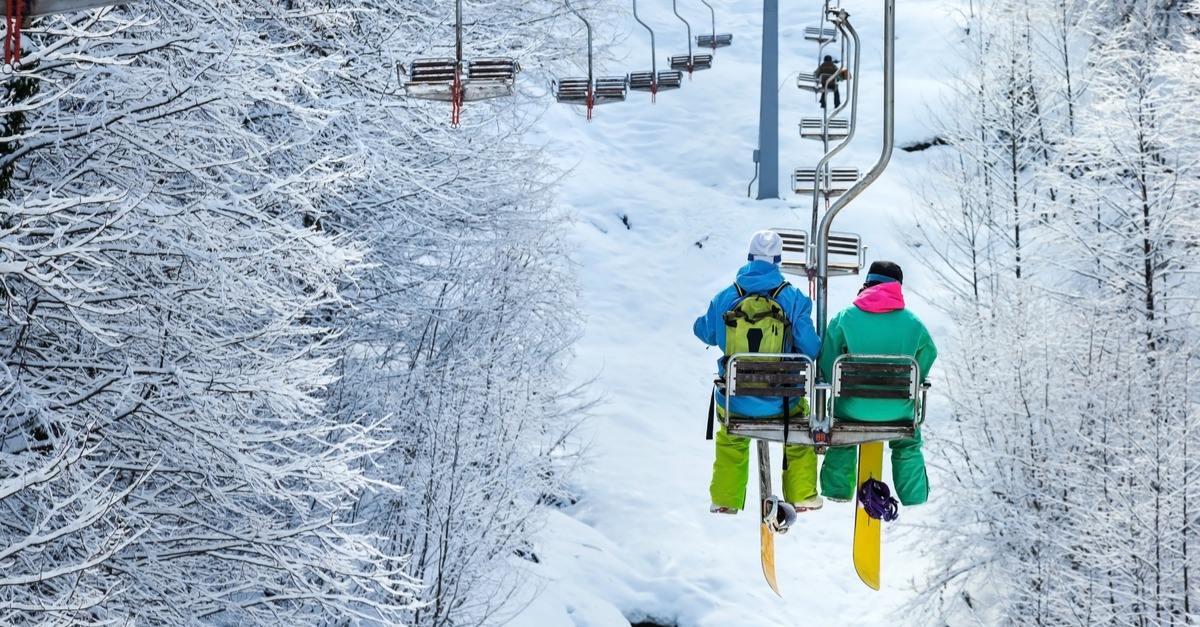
691, 261, 821, 417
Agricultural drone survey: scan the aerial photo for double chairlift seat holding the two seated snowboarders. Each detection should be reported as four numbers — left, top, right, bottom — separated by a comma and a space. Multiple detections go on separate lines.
718, 353, 929, 449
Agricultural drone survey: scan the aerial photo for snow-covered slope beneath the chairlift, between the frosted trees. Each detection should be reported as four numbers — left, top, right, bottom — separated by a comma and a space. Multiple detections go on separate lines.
510, 0, 953, 627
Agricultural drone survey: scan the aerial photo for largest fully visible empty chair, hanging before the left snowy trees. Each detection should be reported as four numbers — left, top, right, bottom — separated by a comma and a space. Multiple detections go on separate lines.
404, 0, 520, 126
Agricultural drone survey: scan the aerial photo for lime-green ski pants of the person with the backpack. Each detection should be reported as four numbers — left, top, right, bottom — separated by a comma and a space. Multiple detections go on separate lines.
708, 424, 817, 509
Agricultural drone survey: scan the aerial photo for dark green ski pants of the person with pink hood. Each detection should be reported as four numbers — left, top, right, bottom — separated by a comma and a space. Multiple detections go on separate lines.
821, 429, 929, 506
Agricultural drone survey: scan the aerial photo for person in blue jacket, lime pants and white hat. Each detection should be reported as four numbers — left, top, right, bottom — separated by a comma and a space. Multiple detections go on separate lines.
692, 231, 822, 513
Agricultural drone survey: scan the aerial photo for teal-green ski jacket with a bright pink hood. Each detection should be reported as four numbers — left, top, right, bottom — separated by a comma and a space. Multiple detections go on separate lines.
817, 282, 937, 422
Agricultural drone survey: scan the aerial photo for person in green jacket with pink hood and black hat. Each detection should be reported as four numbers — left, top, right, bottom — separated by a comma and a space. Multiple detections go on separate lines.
817, 261, 937, 506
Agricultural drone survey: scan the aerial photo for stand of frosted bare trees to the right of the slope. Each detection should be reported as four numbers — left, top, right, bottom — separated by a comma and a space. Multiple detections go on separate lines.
912, 1, 1200, 625
